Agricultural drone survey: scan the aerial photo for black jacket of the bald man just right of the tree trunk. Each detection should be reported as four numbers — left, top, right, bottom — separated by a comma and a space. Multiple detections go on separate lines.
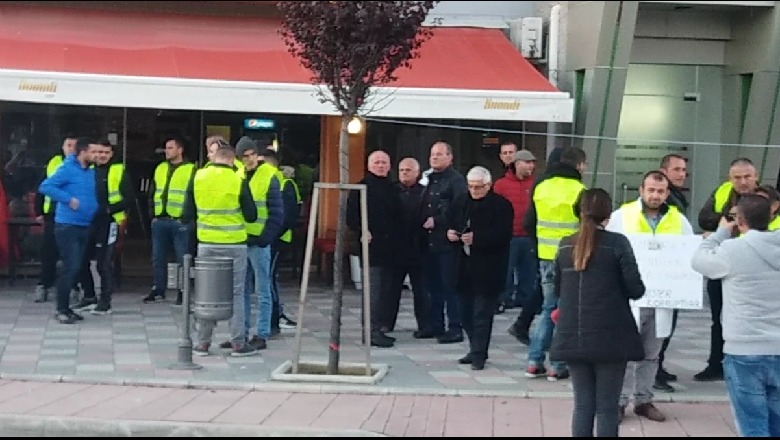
347, 173, 403, 266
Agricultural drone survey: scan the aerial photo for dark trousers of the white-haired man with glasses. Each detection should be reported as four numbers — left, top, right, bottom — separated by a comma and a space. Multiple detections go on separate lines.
459, 280, 500, 361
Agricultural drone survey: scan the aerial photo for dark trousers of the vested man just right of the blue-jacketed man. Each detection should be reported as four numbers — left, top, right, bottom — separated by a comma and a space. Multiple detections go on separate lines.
81, 223, 114, 305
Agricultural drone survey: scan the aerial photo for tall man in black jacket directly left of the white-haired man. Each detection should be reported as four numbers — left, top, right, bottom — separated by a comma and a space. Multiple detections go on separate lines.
414, 142, 468, 344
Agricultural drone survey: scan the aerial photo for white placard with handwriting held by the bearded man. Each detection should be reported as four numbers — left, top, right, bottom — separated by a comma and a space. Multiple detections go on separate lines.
626, 234, 704, 310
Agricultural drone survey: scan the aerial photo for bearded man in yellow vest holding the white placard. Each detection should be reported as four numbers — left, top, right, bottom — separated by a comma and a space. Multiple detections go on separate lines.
607, 170, 693, 422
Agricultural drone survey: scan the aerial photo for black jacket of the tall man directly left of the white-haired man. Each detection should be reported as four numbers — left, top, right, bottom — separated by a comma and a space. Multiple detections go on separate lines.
423, 167, 468, 253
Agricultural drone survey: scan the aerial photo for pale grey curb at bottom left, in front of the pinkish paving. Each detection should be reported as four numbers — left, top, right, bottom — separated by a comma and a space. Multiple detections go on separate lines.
0, 414, 386, 437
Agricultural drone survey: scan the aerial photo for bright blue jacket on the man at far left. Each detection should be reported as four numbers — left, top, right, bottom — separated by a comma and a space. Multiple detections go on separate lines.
38, 154, 98, 226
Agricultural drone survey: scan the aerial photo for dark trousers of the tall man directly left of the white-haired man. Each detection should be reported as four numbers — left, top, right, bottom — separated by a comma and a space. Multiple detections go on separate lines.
423, 251, 463, 335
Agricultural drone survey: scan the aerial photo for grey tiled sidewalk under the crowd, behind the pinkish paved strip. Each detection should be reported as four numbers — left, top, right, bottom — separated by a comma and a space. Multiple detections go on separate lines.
0, 280, 727, 402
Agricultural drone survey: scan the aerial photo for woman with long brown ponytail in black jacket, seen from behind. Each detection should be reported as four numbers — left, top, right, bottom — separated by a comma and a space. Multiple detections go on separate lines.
550, 189, 645, 437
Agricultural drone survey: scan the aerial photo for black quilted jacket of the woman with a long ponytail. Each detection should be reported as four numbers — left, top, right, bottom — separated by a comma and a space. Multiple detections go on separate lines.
550, 229, 645, 362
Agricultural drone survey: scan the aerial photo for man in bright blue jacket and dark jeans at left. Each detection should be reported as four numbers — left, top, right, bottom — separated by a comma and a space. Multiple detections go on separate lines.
38, 137, 98, 324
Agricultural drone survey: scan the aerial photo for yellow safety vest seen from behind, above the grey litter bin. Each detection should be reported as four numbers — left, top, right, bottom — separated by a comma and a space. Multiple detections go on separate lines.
193, 167, 246, 244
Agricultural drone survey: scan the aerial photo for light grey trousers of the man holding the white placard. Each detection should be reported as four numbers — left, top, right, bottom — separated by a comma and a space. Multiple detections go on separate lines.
620, 308, 664, 406
